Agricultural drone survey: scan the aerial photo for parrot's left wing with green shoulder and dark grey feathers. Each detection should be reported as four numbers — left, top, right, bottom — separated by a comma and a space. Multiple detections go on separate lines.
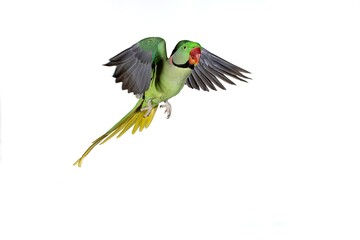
104, 37, 167, 94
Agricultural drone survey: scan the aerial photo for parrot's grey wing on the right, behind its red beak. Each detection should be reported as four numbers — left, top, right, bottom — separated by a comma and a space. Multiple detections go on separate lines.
186, 48, 251, 91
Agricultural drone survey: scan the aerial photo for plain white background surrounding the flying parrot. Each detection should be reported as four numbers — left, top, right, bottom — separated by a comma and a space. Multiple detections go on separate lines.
0, 0, 360, 240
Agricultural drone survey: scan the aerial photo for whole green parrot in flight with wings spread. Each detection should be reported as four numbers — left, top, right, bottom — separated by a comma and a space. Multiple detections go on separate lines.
74, 37, 250, 167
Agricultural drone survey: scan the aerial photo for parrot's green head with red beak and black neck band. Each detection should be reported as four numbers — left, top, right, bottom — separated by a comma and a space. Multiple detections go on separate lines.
170, 40, 201, 69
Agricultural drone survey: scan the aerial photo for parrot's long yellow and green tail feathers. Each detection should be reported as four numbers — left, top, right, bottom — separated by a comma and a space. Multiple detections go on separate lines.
73, 99, 158, 167
